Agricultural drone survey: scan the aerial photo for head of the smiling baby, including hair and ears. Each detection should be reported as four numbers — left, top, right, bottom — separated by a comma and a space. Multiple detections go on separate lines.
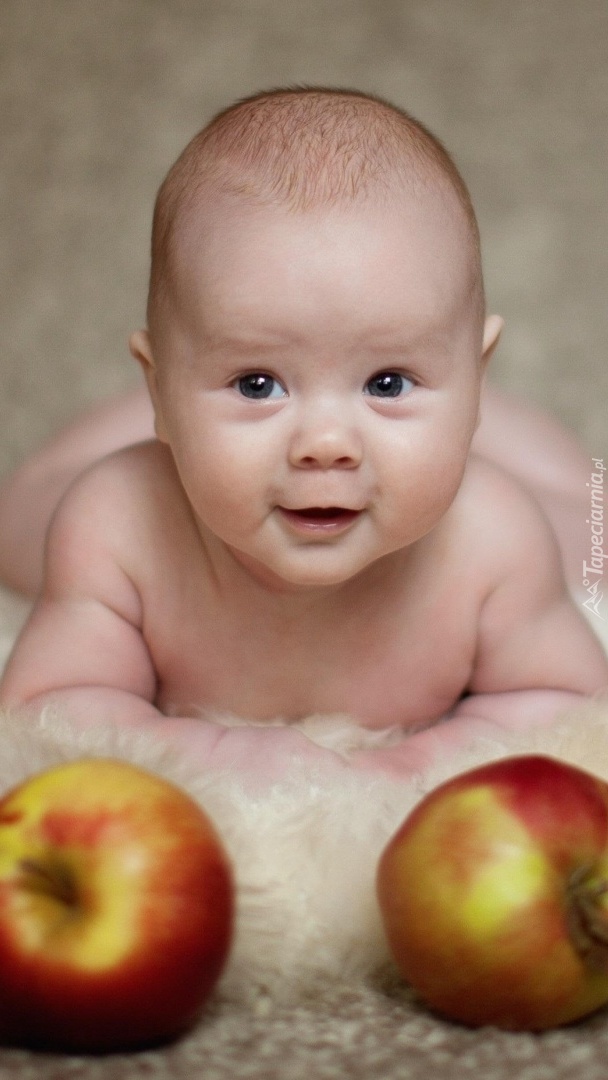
132, 90, 499, 586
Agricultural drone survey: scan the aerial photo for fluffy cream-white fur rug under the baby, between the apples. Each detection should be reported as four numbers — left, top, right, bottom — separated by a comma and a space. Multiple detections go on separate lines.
0, 594, 608, 1012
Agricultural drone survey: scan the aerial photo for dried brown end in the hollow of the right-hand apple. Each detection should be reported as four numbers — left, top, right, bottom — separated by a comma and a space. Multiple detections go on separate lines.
566, 866, 608, 974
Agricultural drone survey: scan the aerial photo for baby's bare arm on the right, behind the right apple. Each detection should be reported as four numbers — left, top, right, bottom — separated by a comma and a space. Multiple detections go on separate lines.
354, 474, 608, 775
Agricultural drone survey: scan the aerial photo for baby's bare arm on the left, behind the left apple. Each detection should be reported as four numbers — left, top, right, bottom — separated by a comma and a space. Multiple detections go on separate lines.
0, 467, 343, 785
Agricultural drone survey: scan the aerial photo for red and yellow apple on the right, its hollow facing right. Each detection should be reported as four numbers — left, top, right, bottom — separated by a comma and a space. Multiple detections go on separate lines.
377, 756, 608, 1030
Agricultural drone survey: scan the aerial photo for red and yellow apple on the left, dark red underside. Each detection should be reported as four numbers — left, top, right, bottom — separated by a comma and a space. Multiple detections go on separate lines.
0, 758, 233, 1052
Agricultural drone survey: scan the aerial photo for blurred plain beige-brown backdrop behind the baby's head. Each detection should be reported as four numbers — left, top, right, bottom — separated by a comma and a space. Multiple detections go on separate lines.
0, 0, 608, 473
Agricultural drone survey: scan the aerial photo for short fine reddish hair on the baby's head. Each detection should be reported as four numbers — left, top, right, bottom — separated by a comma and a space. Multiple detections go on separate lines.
148, 86, 484, 324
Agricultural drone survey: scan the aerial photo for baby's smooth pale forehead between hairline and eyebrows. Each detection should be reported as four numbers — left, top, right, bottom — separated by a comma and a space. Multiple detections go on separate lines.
167, 197, 473, 356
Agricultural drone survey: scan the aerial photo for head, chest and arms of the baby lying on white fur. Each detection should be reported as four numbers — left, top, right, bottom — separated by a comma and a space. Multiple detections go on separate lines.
0, 89, 608, 779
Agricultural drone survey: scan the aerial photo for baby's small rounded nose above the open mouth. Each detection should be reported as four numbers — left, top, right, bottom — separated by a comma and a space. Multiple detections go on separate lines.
289, 408, 363, 469
